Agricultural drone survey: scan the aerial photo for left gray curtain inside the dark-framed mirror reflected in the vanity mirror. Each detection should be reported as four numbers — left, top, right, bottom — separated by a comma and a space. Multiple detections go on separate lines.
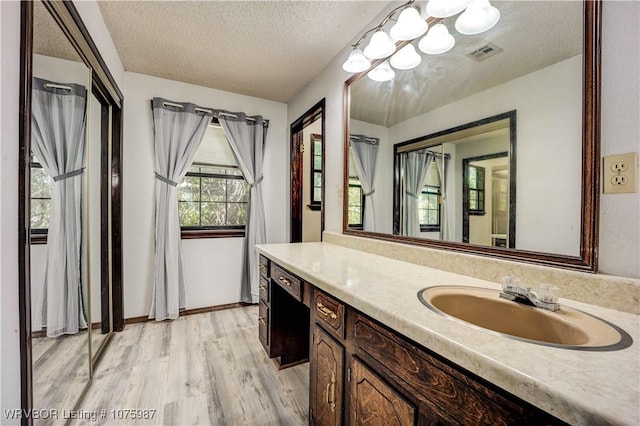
402, 150, 432, 237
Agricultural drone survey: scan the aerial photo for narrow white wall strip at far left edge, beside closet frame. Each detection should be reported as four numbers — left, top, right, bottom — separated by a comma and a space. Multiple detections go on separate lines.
0, 1, 20, 424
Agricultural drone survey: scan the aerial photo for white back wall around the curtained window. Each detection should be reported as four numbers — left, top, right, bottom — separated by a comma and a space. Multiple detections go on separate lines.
122, 72, 288, 318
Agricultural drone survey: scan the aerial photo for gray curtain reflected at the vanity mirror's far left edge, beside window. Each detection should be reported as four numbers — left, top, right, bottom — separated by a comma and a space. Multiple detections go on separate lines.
350, 135, 380, 231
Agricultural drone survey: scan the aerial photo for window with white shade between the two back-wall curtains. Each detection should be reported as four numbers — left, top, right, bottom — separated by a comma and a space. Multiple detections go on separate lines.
178, 125, 250, 238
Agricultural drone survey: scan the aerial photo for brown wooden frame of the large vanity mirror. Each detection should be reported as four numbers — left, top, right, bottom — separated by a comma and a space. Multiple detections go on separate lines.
342, 0, 602, 273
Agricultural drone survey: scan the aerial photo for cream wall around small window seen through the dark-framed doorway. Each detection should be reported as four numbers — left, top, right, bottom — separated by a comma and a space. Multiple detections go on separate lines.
302, 118, 322, 242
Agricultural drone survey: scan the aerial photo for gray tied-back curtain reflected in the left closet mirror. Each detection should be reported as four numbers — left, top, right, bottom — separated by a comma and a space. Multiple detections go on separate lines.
31, 78, 87, 336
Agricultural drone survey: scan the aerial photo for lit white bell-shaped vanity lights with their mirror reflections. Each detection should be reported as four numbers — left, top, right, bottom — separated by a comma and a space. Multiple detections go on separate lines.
342, 0, 500, 81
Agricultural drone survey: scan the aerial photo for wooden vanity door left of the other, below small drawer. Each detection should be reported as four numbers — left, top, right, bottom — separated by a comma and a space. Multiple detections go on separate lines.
310, 325, 344, 426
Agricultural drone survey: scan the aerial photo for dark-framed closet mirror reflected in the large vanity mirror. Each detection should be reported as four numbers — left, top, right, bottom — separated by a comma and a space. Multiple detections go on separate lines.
394, 111, 517, 248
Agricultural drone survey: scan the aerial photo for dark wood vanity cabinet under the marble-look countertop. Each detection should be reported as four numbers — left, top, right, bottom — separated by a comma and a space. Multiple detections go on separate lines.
259, 258, 564, 426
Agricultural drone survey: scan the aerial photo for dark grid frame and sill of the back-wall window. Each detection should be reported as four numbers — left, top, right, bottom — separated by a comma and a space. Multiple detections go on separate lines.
178, 164, 251, 240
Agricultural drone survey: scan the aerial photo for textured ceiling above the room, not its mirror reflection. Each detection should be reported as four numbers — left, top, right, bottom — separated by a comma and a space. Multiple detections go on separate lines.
98, 1, 388, 102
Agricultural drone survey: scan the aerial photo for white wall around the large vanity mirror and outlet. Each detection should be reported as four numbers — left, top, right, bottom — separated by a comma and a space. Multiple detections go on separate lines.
289, 1, 640, 277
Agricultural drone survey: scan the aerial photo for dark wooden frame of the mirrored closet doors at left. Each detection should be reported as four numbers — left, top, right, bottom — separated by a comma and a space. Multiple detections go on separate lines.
17, 0, 124, 425
